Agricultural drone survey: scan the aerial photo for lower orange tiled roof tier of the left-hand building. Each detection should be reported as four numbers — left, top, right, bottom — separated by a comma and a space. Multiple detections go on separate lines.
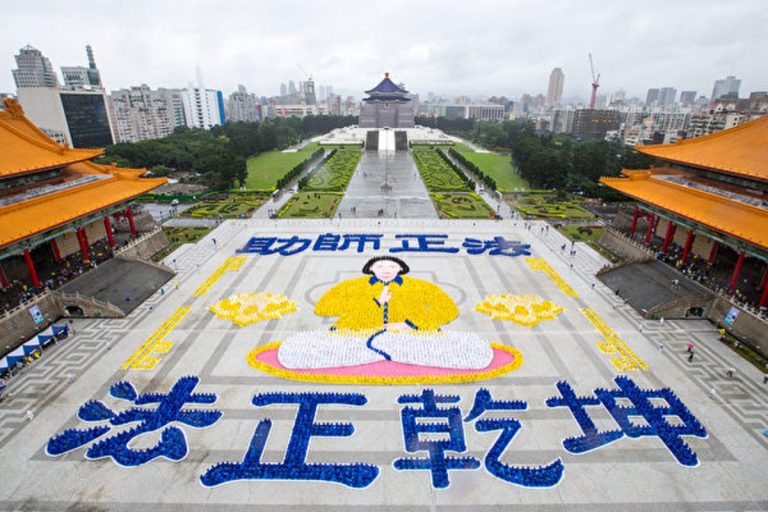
0, 168, 167, 247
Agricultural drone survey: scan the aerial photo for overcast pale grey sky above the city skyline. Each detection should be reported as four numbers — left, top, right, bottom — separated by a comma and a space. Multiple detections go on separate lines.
0, 0, 768, 98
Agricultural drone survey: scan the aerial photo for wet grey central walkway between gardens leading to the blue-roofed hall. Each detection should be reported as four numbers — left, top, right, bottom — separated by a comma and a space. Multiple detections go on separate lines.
337, 151, 438, 219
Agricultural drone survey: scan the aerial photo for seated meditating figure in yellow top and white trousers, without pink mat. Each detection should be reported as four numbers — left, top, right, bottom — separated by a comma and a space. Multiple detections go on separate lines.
278, 256, 493, 369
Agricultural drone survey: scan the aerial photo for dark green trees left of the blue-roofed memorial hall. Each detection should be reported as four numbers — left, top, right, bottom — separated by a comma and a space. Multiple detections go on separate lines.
98, 116, 357, 190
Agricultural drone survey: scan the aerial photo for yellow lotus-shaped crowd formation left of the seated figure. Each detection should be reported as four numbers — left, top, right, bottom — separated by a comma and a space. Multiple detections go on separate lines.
208, 292, 296, 327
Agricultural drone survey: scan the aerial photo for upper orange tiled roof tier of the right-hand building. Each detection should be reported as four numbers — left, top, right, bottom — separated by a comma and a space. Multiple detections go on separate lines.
635, 115, 768, 181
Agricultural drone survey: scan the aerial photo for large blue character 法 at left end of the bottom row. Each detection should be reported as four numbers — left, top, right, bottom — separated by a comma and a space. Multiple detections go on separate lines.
46, 376, 222, 467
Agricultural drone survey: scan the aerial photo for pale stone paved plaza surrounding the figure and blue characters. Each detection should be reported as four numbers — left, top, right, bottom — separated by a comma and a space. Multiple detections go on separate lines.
0, 217, 768, 511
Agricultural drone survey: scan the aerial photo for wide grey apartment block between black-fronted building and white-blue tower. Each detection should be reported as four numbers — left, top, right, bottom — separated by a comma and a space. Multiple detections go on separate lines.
110, 84, 184, 142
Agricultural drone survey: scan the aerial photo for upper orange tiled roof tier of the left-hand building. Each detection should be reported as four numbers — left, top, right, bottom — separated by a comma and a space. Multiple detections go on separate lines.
0, 98, 104, 179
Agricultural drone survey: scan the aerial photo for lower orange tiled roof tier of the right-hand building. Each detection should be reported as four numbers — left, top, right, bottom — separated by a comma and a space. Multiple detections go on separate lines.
600, 170, 768, 250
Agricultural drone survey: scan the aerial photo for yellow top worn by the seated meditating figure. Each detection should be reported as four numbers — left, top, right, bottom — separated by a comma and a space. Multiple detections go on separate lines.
315, 276, 459, 331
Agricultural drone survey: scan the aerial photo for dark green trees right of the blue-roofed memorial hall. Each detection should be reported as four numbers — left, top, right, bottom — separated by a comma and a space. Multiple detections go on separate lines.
416, 118, 653, 200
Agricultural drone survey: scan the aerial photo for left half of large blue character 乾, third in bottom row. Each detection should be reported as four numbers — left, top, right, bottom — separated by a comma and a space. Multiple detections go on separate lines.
394, 389, 480, 488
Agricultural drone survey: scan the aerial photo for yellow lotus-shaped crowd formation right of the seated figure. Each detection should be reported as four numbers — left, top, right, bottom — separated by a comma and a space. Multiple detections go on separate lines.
475, 293, 563, 327
